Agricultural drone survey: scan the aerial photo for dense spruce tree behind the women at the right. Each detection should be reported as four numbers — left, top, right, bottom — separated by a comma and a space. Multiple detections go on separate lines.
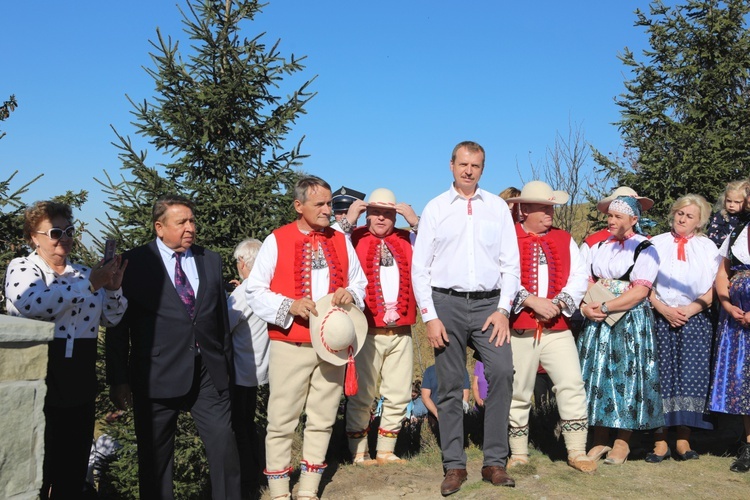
594, 0, 750, 232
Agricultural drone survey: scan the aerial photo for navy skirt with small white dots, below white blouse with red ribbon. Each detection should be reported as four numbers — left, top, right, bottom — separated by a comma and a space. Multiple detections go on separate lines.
655, 310, 713, 429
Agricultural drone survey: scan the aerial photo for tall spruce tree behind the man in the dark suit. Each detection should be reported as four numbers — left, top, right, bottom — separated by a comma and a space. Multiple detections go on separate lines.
100, 0, 314, 277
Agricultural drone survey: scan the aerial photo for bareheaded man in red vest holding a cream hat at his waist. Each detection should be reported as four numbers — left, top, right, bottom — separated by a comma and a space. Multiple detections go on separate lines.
247, 176, 367, 500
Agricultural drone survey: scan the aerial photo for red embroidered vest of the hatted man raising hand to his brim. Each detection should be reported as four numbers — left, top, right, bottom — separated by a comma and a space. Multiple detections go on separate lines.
352, 227, 417, 328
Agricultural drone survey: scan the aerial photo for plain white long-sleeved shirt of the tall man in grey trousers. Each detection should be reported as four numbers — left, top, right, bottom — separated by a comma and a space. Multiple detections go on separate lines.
412, 185, 521, 322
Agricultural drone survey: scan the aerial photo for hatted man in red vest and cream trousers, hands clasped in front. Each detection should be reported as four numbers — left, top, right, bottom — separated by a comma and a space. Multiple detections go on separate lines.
508, 181, 596, 472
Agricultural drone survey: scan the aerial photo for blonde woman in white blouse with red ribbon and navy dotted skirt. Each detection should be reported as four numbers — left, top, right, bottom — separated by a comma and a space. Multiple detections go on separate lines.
646, 194, 721, 463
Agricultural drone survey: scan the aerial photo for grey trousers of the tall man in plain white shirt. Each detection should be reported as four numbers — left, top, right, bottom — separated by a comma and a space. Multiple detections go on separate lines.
432, 292, 513, 470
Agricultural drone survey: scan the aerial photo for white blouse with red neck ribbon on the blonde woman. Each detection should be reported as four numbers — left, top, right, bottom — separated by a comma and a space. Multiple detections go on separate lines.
651, 232, 721, 307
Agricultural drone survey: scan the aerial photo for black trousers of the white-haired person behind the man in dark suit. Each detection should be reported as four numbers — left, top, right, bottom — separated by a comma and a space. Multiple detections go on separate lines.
232, 385, 261, 497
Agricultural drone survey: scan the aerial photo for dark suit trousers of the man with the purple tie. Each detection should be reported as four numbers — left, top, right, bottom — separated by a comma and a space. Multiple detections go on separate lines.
133, 356, 240, 500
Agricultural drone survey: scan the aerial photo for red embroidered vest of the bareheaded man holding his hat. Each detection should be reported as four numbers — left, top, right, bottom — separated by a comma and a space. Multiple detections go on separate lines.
268, 222, 349, 344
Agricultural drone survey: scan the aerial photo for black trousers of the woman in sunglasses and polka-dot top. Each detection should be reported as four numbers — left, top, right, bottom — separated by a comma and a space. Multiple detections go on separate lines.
40, 401, 94, 500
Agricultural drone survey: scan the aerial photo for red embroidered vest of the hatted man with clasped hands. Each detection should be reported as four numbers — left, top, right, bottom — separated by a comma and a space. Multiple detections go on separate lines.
511, 223, 571, 330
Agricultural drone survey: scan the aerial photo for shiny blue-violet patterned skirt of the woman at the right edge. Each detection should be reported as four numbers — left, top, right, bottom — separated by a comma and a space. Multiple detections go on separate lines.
709, 270, 750, 415
